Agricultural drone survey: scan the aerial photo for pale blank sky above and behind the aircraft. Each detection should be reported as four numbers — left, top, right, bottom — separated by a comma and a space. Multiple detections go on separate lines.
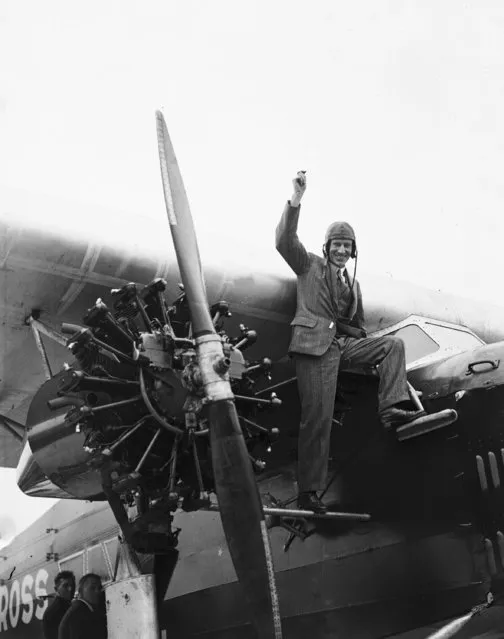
0, 0, 504, 548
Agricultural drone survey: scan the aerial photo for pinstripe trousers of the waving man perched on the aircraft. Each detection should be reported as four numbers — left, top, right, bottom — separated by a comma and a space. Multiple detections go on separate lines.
295, 336, 409, 493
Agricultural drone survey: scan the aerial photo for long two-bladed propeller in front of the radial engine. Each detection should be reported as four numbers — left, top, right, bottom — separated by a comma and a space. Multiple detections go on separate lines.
156, 111, 282, 639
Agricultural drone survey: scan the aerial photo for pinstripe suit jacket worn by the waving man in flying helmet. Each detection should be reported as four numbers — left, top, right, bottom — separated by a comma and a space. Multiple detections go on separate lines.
276, 202, 366, 356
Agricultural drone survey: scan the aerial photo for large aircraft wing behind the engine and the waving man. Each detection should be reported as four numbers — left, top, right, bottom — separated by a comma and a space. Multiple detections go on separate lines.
0, 187, 504, 467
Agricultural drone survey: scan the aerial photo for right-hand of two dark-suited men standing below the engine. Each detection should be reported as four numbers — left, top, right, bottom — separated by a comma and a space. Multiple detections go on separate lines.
58, 572, 107, 639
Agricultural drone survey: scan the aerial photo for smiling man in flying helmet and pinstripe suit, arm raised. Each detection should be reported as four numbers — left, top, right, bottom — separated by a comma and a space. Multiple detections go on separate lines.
276, 172, 440, 513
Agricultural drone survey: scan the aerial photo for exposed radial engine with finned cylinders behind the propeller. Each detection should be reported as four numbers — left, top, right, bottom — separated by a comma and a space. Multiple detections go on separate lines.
20, 279, 281, 554
